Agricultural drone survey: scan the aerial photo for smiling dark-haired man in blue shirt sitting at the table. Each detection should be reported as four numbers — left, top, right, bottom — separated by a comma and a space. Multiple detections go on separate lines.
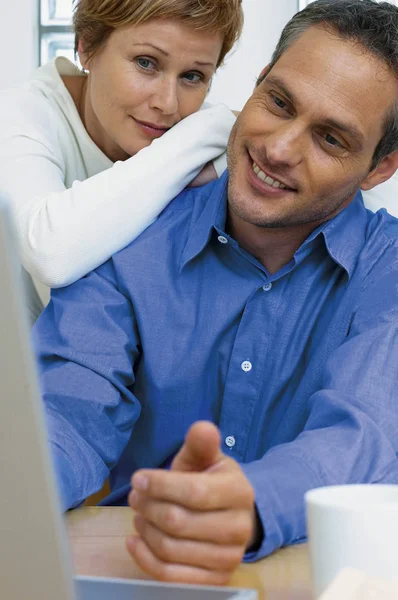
36, 0, 398, 584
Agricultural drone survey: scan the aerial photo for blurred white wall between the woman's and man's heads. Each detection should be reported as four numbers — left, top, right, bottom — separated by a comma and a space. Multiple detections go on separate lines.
208, 0, 298, 110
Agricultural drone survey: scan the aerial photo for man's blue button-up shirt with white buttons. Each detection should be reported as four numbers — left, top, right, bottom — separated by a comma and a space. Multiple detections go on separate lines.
35, 175, 398, 558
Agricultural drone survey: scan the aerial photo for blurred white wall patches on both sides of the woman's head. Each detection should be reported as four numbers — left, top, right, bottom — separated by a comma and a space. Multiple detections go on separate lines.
0, 0, 298, 103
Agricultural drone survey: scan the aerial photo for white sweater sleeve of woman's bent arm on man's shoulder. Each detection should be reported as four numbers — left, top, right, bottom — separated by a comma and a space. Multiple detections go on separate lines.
0, 100, 235, 288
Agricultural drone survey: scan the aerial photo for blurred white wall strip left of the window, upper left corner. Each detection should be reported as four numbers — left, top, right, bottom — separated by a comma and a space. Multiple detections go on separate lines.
0, 0, 38, 88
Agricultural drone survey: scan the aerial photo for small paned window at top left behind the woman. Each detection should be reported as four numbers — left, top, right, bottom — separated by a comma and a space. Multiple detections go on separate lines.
39, 0, 75, 64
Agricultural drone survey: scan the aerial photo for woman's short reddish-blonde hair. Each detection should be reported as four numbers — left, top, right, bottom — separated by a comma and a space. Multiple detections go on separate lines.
73, 0, 243, 66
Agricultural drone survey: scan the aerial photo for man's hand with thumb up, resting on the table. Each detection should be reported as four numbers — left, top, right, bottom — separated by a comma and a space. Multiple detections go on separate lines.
127, 422, 256, 585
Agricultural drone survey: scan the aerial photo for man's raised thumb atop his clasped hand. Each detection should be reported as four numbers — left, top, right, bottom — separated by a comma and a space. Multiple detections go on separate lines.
171, 421, 225, 471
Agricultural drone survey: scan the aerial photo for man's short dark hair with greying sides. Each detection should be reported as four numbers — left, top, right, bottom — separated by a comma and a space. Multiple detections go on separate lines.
260, 0, 398, 170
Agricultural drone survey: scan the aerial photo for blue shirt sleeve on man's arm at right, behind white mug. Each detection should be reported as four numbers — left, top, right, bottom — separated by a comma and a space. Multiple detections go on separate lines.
243, 265, 398, 561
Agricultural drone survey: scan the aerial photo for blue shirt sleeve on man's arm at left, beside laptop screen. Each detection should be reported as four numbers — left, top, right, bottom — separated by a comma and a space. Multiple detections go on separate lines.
33, 261, 141, 510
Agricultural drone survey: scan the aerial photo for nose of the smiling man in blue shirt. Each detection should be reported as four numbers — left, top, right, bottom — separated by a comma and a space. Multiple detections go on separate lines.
265, 123, 306, 167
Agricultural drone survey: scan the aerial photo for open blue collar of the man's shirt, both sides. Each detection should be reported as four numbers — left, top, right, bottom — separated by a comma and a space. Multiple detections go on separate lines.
181, 171, 368, 278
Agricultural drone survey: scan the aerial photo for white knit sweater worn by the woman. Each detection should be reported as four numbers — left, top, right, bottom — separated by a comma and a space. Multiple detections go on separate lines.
0, 58, 235, 318
